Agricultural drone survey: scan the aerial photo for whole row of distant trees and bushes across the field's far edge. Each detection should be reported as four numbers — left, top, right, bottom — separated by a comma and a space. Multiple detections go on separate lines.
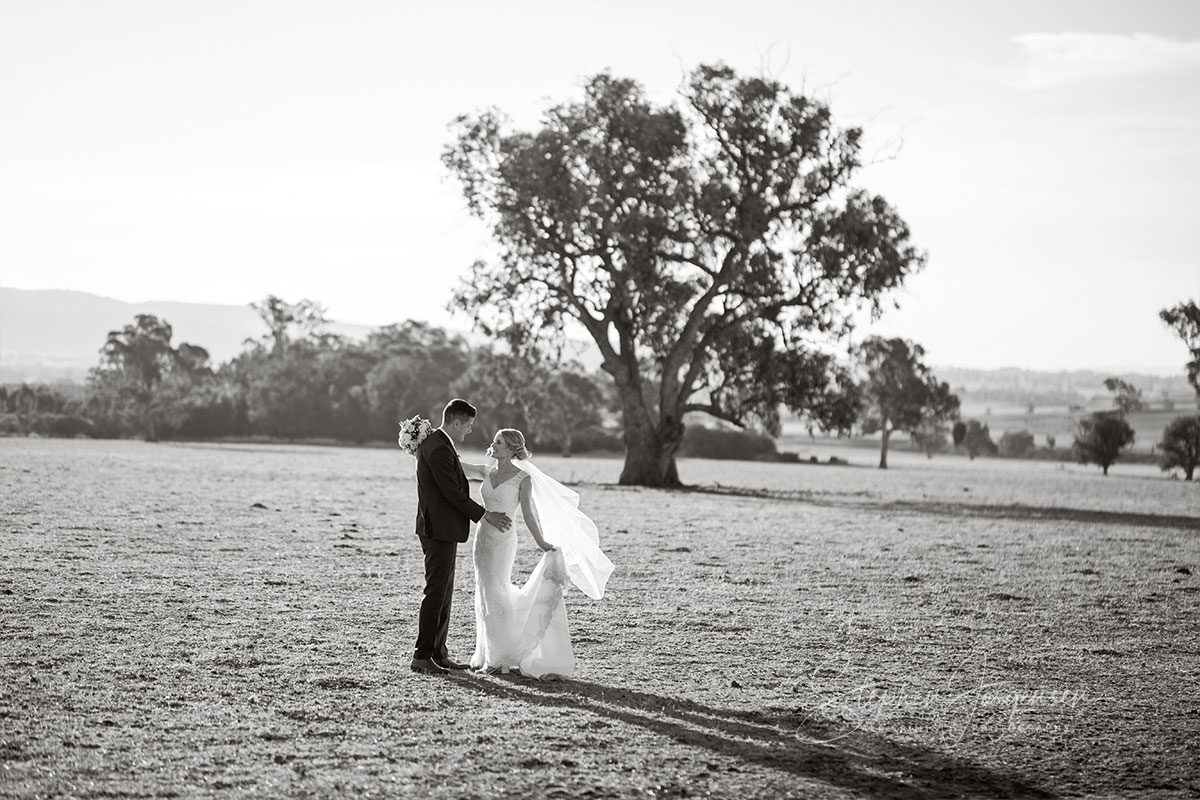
0, 295, 1200, 480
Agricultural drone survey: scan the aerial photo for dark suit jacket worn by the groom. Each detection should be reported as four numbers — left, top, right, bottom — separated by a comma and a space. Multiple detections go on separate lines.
416, 431, 484, 542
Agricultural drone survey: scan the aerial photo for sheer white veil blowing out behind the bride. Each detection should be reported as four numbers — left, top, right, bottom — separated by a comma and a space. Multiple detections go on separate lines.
512, 459, 612, 600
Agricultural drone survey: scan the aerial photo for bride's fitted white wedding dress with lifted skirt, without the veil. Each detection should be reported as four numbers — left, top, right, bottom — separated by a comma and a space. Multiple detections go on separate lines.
470, 467, 575, 678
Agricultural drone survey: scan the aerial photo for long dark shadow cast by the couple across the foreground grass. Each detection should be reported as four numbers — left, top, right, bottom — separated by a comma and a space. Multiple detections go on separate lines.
472, 676, 1055, 800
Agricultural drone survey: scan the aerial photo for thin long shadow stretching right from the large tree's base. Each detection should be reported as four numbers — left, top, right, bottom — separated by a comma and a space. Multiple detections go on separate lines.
683, 486, 1200, 530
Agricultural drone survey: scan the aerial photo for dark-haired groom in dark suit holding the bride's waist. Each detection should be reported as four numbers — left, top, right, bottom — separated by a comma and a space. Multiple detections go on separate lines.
412, 399, 512, 675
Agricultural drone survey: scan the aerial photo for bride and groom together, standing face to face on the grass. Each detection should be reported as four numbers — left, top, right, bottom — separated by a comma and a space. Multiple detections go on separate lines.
412, 399, 612, 679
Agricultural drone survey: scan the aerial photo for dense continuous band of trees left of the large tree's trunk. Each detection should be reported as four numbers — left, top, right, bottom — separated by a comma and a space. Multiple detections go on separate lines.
0, 296, 620, 452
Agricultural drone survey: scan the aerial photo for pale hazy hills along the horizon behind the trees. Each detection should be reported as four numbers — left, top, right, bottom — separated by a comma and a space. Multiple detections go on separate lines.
0, 287, 1193, 405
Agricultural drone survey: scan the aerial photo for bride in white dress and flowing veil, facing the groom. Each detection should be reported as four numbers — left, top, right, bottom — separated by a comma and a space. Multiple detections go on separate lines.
462, 428, 612, 679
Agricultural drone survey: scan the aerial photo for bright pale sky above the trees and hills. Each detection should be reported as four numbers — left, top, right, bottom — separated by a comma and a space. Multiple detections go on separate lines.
0, 0, 1200, 369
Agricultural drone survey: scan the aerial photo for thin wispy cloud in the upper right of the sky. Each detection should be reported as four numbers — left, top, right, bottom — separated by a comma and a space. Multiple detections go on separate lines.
1013, 34, 1200, 89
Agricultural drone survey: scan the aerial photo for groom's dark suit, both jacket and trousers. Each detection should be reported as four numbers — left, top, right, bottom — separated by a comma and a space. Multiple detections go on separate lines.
413, 431, 484, 658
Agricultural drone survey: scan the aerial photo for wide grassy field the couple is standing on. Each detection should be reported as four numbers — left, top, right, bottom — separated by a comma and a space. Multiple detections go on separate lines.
0, 439, 1200, 798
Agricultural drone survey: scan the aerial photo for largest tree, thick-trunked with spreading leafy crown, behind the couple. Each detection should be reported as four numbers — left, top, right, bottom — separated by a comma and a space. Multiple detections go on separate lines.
443, 65, 924, 486
